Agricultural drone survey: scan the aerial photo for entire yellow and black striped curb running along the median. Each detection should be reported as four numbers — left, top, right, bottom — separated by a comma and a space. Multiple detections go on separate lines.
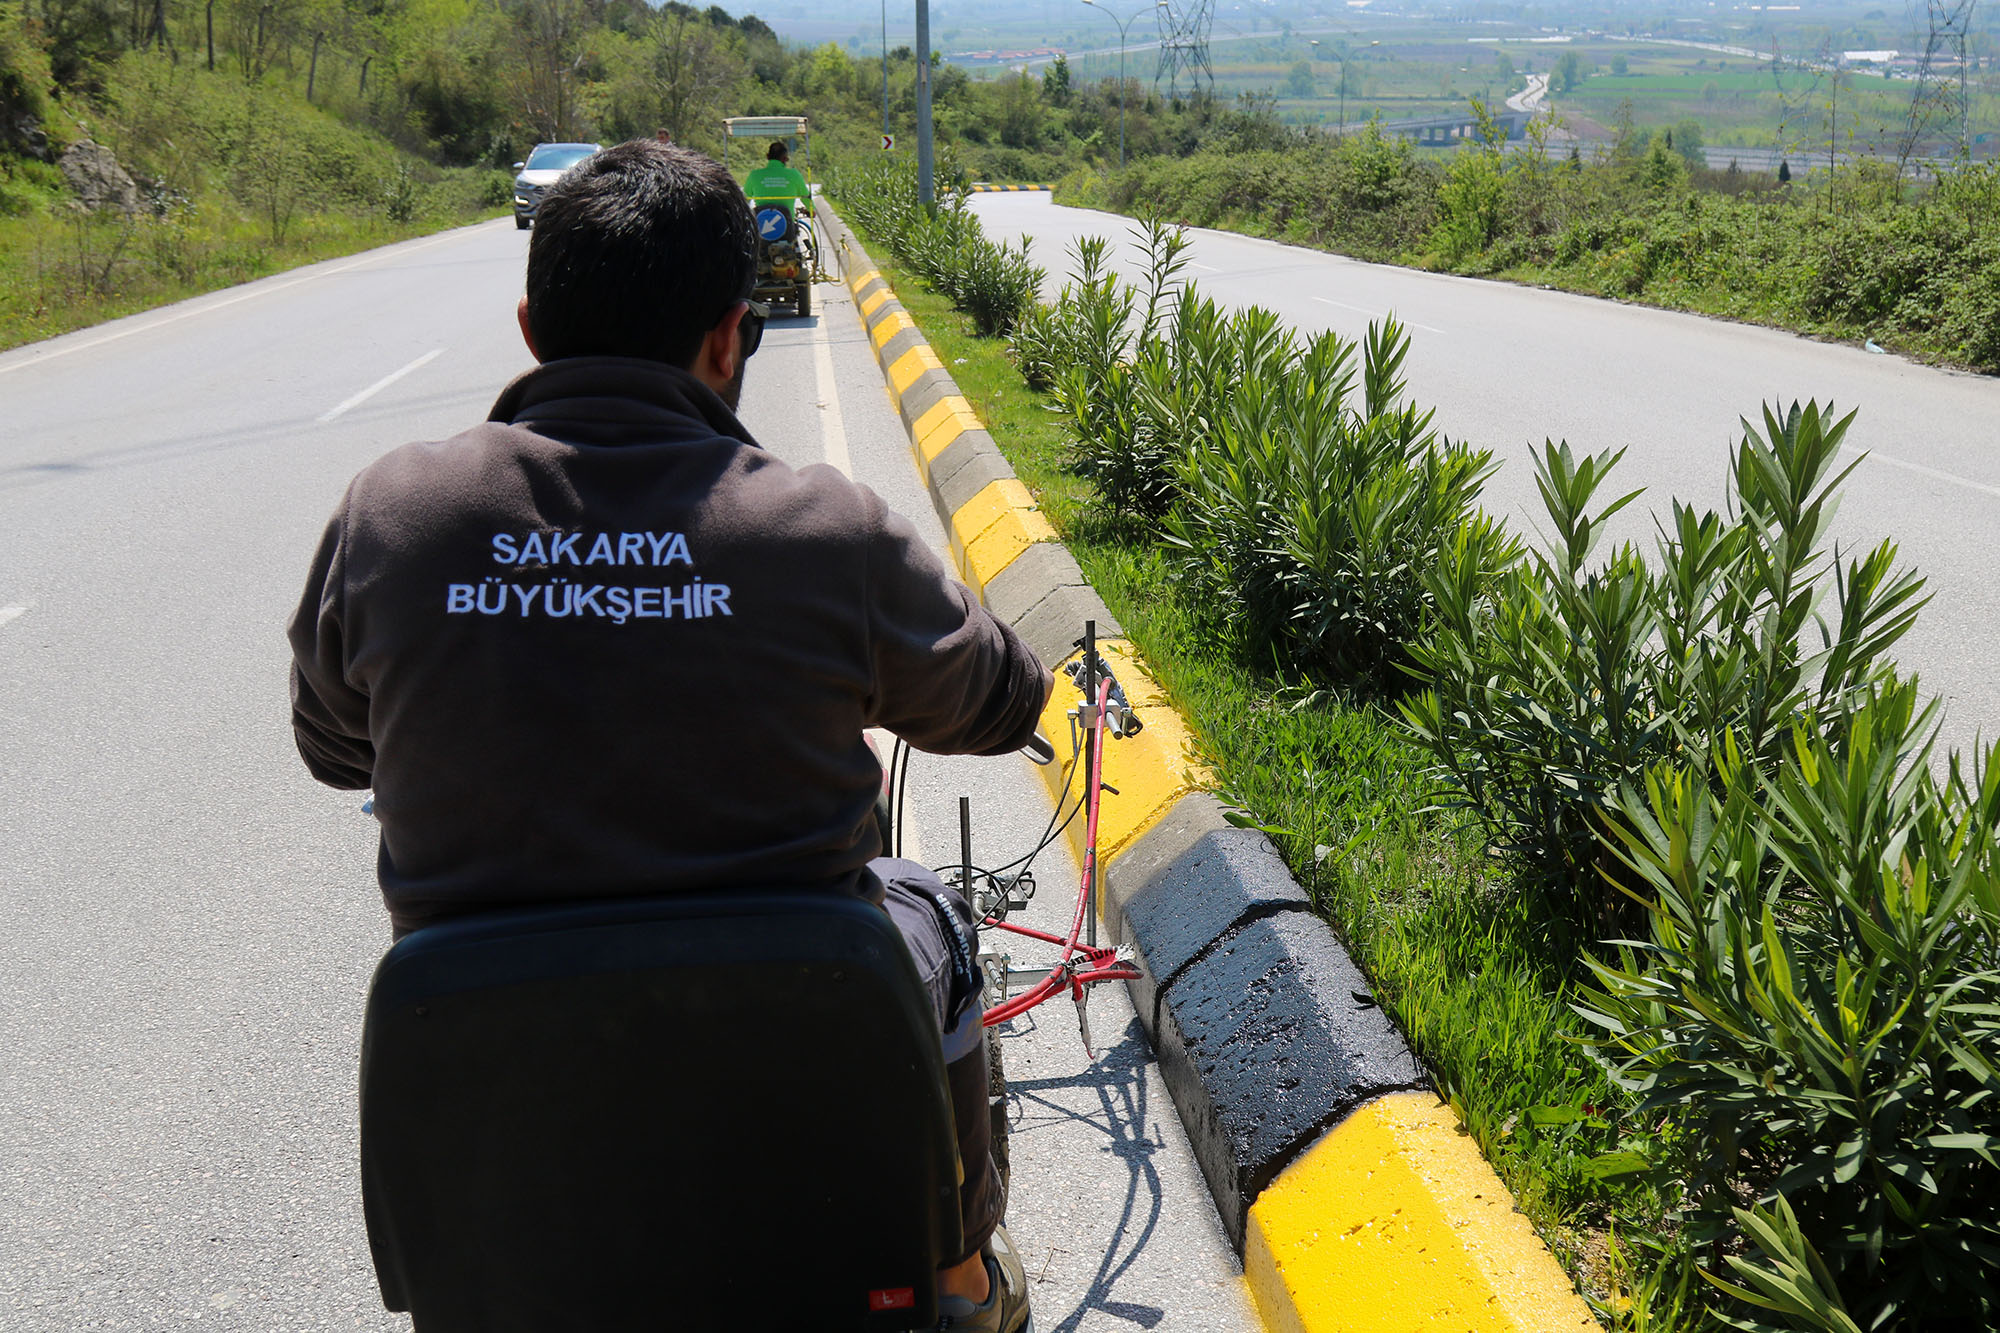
820, 208, 1598, 1333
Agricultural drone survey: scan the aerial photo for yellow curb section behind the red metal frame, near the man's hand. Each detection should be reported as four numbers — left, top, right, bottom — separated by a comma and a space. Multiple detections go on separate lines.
1036, 640, 1214, 871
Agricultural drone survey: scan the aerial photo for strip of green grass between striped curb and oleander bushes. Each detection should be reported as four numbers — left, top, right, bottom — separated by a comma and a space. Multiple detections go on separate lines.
852, 218, 1652, 1295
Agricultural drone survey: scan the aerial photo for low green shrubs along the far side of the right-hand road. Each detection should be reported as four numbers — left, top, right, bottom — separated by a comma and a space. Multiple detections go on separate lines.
1062, 104, 2000, 374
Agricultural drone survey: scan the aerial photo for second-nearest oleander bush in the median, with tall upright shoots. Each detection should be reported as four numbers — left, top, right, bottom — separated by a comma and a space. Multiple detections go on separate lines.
1402, 404, 1922, 937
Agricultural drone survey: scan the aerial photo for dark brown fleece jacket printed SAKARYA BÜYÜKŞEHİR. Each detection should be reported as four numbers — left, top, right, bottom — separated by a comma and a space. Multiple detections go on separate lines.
292, 356, 1050, 929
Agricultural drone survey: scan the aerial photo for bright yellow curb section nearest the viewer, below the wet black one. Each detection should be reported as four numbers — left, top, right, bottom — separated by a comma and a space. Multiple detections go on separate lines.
1248, 1088, 1598, 1333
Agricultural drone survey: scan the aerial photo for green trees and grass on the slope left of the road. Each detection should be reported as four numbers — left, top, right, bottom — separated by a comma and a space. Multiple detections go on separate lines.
0, 0, 1274, 346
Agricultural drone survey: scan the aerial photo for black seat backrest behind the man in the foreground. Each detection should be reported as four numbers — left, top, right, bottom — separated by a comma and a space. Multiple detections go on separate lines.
360, 893, 960, 1333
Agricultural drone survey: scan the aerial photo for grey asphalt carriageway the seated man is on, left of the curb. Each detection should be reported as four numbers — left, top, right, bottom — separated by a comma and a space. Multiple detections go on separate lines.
0, 220, 1252, 1333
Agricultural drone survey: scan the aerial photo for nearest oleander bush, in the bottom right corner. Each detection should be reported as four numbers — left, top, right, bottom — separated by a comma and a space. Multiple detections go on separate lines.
1580, 677, 2000, 1333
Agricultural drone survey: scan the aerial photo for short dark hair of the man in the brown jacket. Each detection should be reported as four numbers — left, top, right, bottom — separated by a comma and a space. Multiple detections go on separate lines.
528, 138, 756, 368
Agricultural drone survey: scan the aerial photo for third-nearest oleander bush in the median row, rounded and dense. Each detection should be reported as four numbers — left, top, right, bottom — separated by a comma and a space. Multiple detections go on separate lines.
1166, 310, 1512, 693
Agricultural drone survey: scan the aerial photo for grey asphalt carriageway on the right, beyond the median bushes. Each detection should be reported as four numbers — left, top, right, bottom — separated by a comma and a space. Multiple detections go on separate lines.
972, 194, 2000, 747
